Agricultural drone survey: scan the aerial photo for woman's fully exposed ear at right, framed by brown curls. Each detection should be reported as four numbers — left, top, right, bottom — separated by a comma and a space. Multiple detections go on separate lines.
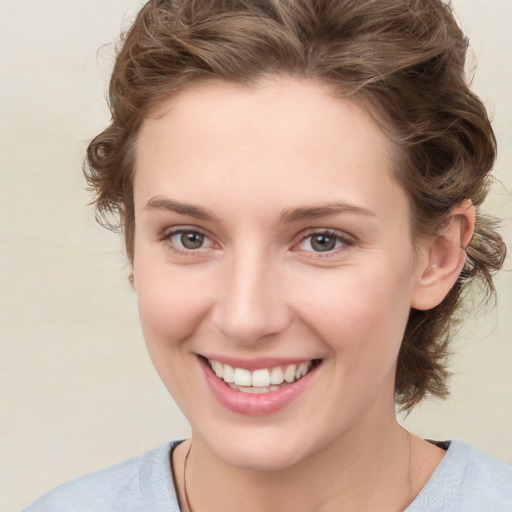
411, 199, 475, 310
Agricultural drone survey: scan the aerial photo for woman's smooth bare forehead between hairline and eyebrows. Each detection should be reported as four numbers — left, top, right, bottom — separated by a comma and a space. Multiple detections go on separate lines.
134, 79, 403, 220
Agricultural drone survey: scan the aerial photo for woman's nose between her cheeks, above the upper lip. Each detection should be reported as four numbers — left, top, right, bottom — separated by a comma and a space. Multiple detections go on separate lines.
213, 248, 290, 344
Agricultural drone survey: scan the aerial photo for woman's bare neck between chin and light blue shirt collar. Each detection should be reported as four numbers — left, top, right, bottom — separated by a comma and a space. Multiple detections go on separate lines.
173, 412, 440, 512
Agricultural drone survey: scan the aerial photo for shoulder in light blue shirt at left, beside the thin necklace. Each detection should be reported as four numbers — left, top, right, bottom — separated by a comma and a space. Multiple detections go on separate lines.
23, 443, 179, 512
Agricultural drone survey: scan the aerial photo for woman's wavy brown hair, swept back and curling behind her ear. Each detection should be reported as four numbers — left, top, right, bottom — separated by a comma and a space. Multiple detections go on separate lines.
85, 0, 505, 410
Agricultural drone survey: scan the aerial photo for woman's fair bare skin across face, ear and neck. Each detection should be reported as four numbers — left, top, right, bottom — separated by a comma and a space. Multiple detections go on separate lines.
132, 78, 473, 512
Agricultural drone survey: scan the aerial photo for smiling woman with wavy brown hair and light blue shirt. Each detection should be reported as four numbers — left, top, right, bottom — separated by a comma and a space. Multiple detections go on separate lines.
22, 0, 512, 512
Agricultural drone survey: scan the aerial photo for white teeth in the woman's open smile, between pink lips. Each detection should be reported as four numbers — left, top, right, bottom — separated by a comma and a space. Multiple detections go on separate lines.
203, 358, 321, 394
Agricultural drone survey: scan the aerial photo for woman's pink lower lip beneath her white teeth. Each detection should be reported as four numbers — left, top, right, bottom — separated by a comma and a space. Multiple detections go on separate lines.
199, 357, 318, 416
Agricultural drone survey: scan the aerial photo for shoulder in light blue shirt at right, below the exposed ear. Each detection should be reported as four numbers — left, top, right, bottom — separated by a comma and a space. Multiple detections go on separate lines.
407, 441, 512, 512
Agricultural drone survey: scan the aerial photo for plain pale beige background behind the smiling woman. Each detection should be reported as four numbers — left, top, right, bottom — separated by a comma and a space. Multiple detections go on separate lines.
0, 0, 512, 512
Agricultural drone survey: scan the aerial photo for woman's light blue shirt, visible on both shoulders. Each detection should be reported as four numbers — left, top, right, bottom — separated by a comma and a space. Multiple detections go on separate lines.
22, 441, 512, 512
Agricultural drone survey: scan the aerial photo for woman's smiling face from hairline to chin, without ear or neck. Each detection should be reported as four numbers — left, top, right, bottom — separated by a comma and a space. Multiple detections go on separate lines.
133, 79, 428, 470
